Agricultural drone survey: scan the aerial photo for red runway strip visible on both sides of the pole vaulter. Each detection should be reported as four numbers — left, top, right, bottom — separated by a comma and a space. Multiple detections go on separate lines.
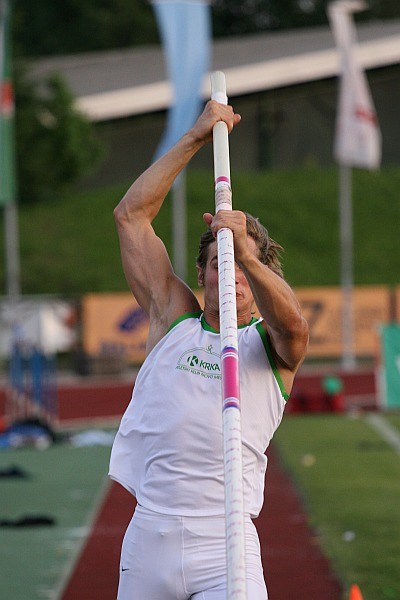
61, 448, 343, 600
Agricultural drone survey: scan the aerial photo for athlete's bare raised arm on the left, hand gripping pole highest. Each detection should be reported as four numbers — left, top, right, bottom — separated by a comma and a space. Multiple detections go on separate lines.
114, 101, 240, 350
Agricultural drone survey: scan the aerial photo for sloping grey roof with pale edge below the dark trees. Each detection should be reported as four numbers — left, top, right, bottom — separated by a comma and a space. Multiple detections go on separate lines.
28, 20, 400, 122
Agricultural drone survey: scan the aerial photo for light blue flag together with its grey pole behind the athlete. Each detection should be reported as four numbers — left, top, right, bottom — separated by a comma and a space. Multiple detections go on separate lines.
150, 0, 212, 281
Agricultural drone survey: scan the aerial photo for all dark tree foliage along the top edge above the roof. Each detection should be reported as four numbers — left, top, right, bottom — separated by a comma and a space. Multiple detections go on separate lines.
13, 0, 400, 57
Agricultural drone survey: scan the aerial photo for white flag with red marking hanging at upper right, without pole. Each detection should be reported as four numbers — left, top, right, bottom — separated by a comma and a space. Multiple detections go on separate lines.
328, 0, 382, 169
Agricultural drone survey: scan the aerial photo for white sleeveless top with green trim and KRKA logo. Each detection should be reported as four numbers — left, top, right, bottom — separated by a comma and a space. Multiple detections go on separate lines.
109, 313, 288, 517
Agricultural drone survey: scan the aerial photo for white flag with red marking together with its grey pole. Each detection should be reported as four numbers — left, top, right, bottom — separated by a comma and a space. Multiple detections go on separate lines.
327, 0, 381, 370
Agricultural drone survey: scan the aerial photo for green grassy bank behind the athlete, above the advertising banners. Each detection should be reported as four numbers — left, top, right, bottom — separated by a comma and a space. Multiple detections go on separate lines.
0, 168, 400, 295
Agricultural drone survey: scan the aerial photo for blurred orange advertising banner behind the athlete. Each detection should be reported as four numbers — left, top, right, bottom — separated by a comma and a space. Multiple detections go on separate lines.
82, 286, 392, 364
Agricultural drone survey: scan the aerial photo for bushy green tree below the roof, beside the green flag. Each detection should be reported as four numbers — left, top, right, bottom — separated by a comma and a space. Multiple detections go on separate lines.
15, 70, 102, 202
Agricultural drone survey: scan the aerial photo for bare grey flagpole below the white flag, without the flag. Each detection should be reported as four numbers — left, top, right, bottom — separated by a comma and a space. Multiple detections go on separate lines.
339, 165, 355, 371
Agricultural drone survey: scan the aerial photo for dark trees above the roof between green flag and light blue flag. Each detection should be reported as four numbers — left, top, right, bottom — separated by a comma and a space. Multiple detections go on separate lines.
13, 0, 158, 57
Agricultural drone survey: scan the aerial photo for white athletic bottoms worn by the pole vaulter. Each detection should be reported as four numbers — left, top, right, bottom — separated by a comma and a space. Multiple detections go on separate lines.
118, 506, 268, 600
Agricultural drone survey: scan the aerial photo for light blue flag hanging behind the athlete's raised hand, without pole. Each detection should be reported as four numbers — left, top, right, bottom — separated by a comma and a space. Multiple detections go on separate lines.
152, 0, 211, 160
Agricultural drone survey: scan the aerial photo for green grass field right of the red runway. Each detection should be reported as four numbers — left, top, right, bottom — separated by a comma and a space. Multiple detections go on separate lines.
274, 416, 400, 600
